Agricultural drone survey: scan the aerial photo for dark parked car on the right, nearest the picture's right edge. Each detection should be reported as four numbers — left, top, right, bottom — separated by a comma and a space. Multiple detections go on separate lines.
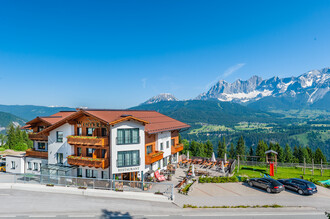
278, 178, 317, 195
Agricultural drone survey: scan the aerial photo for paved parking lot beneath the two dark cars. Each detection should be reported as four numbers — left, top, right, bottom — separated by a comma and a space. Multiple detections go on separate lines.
175, 183, 330, 211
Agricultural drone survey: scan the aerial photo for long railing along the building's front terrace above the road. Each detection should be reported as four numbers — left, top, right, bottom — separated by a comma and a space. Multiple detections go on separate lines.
13, 174, 174, 200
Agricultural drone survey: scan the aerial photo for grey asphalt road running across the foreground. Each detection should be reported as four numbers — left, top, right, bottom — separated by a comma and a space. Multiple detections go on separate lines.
0, 190, 326, 219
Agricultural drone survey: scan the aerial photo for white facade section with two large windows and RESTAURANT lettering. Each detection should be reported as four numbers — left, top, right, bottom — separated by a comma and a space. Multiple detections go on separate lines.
110, 121, 145, 177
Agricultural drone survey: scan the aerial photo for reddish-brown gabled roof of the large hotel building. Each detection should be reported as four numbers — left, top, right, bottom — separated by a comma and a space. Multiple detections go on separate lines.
37, 109, 190, 134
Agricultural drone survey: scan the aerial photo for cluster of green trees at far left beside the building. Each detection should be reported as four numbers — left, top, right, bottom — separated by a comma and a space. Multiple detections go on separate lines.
0, 123, 33, 151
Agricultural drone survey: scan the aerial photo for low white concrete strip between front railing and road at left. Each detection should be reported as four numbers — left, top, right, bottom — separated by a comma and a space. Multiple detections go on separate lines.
0, 183, 172, 203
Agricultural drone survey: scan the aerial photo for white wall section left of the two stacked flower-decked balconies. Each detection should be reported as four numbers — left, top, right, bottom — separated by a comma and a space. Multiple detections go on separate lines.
48, 123, 74, 166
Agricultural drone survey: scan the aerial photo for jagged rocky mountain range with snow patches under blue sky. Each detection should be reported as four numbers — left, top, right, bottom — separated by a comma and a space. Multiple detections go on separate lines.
143, 68, 330, 110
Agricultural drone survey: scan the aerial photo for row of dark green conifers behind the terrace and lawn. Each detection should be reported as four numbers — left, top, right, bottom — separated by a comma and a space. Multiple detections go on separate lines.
181, 136, 327, 164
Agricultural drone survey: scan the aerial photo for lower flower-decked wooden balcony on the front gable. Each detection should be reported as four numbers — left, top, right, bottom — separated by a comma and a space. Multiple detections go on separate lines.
67, 156, 109, 169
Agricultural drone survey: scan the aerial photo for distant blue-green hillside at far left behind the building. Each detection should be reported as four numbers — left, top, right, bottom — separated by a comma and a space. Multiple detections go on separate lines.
0, 105, 73, 121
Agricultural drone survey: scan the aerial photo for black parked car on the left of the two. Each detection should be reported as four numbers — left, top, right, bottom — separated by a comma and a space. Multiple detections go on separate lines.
248, 177, 284, 193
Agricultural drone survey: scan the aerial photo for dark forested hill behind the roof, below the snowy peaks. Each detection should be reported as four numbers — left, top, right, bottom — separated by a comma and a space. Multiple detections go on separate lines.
131, 100, 277, 126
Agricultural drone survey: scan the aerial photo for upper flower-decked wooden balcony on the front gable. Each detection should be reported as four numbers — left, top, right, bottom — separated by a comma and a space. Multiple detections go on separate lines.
67, 135, 109, 147
